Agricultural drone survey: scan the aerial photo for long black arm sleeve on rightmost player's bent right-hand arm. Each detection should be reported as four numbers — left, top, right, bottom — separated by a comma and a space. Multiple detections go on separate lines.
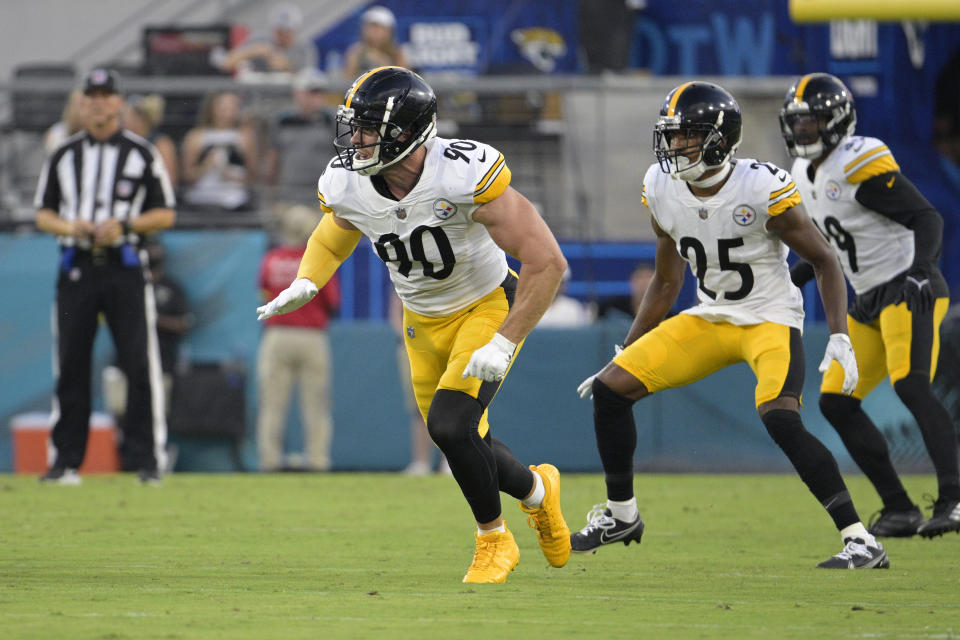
856, 171, 943, 266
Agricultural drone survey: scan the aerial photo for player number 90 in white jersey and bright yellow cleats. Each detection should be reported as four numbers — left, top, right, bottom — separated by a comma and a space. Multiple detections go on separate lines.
257, 67, 570, 582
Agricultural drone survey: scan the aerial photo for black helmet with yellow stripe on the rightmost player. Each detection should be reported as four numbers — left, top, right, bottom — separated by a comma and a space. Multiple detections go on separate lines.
780, 73, 857, 159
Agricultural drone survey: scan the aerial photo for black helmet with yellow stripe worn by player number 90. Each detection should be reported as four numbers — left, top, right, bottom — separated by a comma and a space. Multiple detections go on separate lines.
333, 67, 437, 176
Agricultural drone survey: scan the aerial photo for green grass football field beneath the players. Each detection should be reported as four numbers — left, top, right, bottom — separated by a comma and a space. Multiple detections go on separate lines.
0, 474, 960, 640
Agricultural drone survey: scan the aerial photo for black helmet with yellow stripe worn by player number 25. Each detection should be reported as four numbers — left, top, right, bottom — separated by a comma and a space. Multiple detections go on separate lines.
653, 82, 743, 182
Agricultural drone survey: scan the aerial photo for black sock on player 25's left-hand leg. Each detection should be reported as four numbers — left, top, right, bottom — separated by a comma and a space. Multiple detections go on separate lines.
593, 378, 637, 502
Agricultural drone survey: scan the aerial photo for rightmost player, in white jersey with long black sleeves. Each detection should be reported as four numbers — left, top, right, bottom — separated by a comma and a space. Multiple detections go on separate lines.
780, 73, 960, 538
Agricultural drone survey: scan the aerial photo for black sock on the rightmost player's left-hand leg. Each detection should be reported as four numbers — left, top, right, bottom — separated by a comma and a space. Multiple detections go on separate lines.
820, 393, 913, 511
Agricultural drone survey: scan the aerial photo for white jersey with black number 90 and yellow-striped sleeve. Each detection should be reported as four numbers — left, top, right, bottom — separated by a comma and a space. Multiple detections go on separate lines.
317, 138, 510, 317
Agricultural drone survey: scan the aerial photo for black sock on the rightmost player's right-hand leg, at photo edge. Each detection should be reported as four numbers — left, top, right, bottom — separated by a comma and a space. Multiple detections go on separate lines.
893, 373, 960, 500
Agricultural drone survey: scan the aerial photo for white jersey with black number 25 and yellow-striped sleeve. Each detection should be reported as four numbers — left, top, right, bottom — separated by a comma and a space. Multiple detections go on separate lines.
643, 158, 803, 330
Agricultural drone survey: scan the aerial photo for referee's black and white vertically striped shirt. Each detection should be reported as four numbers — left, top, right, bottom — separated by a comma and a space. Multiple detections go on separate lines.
34, 129, 176, 248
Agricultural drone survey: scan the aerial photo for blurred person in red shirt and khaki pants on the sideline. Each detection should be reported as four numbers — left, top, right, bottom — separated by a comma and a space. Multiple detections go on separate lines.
257, 205, 340, 471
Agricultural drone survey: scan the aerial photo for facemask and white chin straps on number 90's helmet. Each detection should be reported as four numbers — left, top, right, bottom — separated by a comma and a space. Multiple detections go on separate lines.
333, 96, 437, 176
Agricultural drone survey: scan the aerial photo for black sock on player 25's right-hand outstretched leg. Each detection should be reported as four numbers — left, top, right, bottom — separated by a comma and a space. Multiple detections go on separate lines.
762, 409, 860, 530
